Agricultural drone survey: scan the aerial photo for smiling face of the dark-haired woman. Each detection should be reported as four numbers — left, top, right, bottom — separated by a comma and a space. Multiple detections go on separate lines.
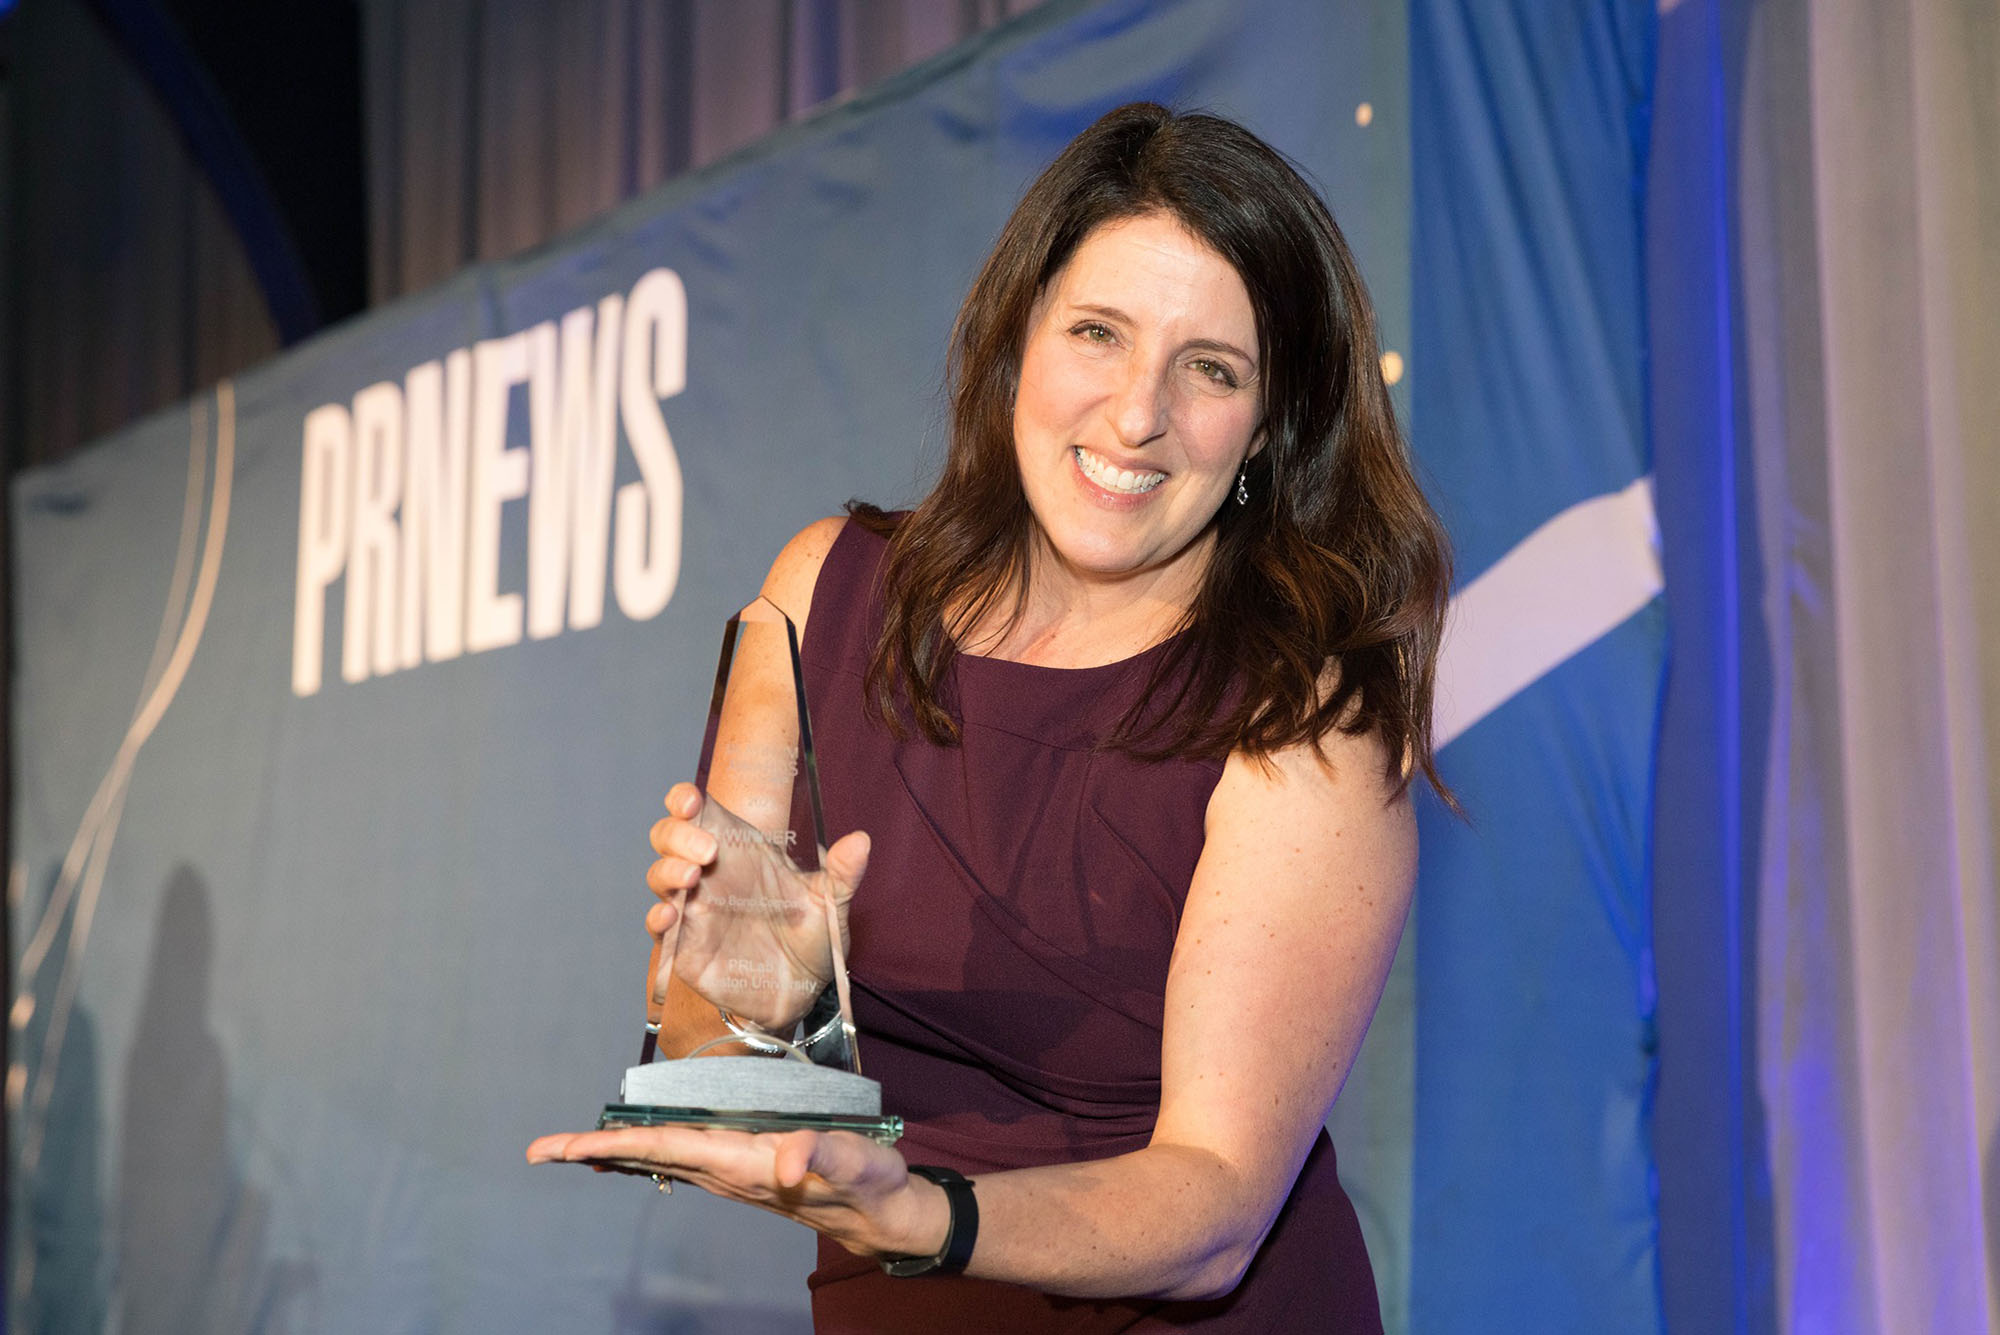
1014, 214, 1264, 596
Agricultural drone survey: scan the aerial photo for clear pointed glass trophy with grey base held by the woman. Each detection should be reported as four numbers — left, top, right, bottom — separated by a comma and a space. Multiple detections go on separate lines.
598, 598, 902, 1143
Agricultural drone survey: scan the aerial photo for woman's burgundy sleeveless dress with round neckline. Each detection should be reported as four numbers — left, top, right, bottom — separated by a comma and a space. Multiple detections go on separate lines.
802, 522, 1382, 1335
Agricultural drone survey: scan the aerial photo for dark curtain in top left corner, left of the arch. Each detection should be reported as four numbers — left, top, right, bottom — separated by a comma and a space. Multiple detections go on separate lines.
0, 0, 278, 466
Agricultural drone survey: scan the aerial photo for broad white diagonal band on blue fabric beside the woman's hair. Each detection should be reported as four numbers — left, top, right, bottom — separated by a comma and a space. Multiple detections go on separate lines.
1430, 474, 1666, 749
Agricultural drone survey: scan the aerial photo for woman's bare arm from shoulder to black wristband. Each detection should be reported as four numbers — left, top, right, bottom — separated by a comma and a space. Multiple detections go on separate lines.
932, 719, 1416, 1297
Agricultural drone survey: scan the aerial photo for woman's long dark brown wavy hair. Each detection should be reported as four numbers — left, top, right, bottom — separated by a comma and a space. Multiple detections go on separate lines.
850, 102, 1450, 803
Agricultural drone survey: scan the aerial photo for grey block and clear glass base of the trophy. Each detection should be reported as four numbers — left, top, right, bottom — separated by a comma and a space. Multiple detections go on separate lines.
598, 1057, 902, 1145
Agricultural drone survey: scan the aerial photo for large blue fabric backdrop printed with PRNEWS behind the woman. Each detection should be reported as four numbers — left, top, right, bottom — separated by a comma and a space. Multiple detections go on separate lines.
8, 0, 1662, 1331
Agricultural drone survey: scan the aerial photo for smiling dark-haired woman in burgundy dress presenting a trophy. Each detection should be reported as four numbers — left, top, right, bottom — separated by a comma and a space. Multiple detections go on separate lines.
528, 106, 1450, 1331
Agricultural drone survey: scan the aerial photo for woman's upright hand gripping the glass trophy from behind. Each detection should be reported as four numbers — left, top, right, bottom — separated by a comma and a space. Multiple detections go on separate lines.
646, 783, 868, 1037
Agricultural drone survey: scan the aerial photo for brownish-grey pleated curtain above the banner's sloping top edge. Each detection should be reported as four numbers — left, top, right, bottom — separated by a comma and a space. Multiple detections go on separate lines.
362, 0, 1038, 304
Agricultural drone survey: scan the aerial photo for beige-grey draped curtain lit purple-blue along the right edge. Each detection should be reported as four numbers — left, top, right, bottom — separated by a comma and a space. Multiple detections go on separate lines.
1740, 0, 2000, 1331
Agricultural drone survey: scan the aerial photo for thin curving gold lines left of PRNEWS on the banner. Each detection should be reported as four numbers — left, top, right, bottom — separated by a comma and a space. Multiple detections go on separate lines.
6, 380, 236, 1191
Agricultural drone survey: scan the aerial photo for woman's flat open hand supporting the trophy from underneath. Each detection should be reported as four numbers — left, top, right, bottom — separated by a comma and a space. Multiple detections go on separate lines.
528, 1127, 950, 1257
